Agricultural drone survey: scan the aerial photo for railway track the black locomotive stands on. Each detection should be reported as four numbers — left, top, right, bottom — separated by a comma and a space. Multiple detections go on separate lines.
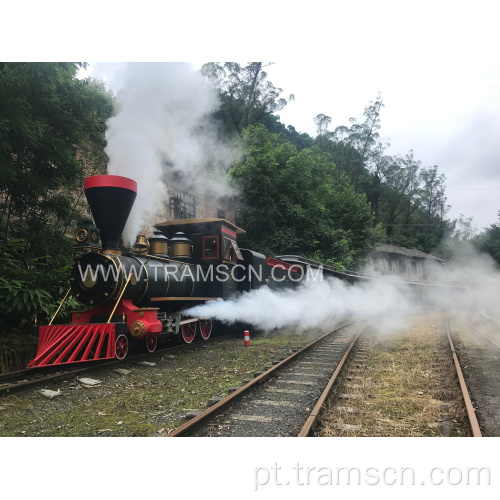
0, 335, 232, 397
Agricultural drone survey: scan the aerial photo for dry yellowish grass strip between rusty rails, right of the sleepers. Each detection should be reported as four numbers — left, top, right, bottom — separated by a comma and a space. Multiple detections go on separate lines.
318, 316, 467, 436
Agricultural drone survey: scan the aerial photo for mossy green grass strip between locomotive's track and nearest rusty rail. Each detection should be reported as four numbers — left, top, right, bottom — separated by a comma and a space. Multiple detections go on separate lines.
0, 330, 328, 436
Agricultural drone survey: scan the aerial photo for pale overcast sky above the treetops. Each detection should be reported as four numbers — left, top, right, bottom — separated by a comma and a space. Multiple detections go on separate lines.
84, 54, 500, 230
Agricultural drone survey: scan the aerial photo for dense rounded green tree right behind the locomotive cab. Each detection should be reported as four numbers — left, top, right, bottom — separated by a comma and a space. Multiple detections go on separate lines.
230, 125, 376, 267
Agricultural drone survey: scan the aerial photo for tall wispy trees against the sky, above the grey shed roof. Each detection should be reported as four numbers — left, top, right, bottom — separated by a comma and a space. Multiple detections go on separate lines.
315, 94, 454, 253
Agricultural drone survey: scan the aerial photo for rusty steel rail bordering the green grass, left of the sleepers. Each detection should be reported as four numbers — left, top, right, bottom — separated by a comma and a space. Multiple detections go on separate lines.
165, 323, 352, 437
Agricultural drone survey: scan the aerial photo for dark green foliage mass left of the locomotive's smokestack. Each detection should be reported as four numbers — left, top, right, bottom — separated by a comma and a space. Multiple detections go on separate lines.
0, 63, 113, 344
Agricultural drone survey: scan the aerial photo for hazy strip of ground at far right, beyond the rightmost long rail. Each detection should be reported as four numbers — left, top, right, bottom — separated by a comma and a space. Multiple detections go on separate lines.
449, 313, 500, 436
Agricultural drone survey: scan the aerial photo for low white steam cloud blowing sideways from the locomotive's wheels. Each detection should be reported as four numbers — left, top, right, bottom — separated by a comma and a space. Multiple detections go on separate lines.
186, 242, 500, 331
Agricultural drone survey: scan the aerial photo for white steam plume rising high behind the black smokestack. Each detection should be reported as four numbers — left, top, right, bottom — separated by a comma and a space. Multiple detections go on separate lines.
105, 63, 233, 245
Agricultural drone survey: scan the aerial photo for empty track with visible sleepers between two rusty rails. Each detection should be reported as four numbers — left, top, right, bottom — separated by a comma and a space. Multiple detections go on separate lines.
168, 324, 364, 437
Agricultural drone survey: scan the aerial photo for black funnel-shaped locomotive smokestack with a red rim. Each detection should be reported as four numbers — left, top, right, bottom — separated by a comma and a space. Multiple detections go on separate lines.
85, 175, 137, 250
